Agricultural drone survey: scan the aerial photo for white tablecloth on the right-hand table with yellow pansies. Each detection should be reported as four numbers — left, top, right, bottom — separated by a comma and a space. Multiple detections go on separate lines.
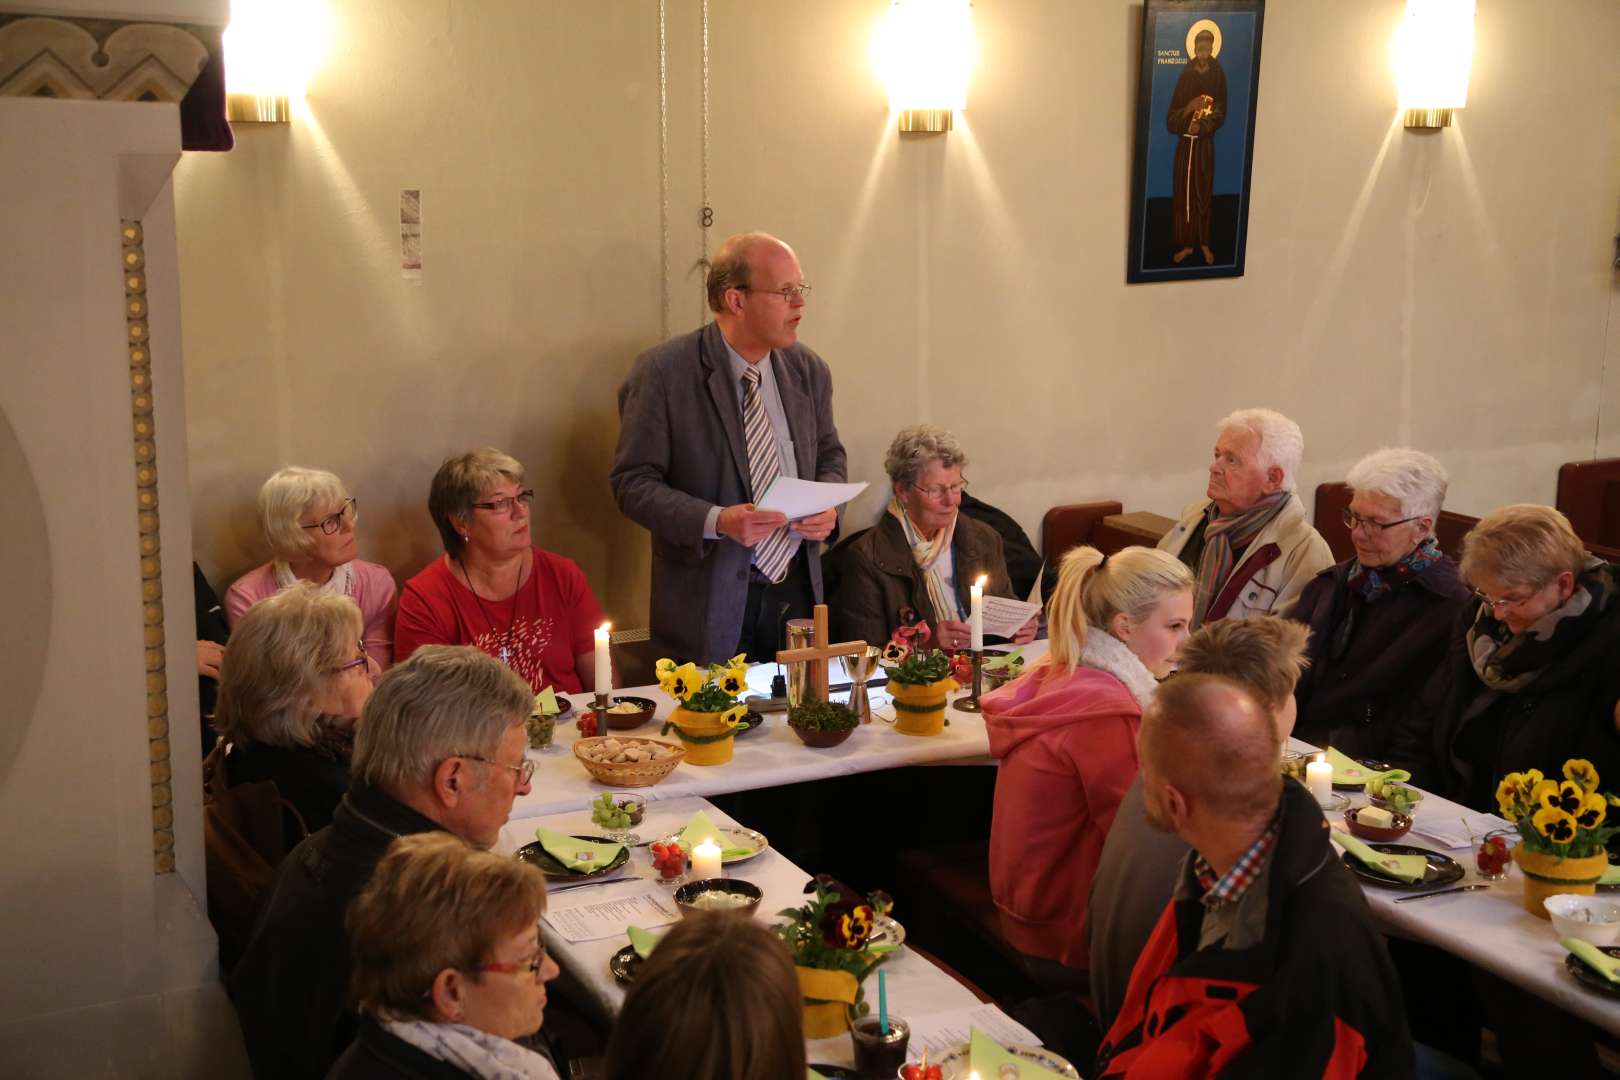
1293, 740, 1620, 1035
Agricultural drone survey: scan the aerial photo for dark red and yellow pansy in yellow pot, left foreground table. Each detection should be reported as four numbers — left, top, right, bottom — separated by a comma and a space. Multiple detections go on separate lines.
776, 874, 896, 1040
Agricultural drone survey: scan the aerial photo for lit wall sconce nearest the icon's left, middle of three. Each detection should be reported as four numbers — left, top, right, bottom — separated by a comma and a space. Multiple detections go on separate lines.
873, 0, 978, 133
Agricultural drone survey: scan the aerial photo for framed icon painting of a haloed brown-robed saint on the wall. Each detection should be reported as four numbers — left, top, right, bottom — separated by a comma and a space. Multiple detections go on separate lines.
1124, 0, 1265, 283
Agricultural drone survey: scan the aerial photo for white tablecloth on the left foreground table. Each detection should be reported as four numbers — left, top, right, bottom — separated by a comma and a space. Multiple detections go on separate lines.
496, 799, 982, 1067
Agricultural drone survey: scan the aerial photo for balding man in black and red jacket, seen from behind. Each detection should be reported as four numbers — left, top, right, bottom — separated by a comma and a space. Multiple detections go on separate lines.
1092, 675, 1416, 1080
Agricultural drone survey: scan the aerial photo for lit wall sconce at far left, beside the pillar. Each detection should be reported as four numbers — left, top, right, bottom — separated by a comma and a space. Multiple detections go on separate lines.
225, 0, 326, 123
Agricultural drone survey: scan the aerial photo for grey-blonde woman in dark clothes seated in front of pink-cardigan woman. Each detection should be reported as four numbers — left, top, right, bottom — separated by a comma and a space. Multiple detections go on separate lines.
214, 581, 371, 832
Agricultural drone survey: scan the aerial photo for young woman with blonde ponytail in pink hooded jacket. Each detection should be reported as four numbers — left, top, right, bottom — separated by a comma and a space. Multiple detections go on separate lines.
983, 547, 1194, 986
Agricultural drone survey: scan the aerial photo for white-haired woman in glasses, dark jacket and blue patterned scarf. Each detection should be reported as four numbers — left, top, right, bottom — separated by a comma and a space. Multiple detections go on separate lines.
1291, 447, 1468, 758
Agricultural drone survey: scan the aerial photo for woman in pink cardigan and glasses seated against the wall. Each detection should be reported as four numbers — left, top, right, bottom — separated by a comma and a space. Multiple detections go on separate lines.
225, 465, 394, 678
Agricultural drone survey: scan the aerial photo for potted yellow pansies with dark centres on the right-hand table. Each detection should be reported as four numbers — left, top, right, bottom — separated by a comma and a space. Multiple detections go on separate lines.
1497, 758, 1620, 918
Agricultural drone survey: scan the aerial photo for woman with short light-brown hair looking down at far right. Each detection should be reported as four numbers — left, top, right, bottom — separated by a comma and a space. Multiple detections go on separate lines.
1390, 504, 1620, 811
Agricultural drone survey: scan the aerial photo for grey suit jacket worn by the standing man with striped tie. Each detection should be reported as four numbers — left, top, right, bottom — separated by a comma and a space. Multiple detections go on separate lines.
611, 322, 846, 664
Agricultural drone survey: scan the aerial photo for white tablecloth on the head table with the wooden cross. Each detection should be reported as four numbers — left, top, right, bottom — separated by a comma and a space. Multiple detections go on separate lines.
512, 641, 1047, 826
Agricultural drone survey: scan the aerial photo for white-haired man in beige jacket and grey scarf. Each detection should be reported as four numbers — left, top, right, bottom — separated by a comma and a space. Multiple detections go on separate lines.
1158, 408, 1333, 627
